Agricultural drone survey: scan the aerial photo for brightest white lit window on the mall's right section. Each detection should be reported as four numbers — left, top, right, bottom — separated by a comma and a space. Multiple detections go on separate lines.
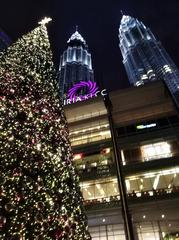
141, 142, 172, 161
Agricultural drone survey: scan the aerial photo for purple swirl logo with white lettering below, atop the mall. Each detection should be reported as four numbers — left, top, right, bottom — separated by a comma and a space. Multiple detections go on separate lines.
63, 81, 107, 105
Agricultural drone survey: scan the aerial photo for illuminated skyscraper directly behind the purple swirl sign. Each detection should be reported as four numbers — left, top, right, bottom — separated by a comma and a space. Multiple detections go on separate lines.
59, 29, 94, 96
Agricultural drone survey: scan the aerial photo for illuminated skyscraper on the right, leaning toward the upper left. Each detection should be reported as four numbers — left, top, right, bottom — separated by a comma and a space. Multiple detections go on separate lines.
119, 15, 179, 107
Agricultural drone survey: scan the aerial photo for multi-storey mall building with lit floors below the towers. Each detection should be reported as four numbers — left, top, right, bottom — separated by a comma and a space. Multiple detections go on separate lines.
65, 81, 179, 240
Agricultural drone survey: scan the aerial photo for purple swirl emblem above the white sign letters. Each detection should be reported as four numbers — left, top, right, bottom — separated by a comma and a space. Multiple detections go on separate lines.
67, 81, 99, 101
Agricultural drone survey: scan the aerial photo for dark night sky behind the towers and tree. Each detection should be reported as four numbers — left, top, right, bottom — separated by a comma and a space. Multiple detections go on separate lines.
0, 0, 179, 90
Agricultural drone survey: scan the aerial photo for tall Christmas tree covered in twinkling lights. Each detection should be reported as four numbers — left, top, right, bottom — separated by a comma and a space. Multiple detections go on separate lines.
0, 17, 91, 240
